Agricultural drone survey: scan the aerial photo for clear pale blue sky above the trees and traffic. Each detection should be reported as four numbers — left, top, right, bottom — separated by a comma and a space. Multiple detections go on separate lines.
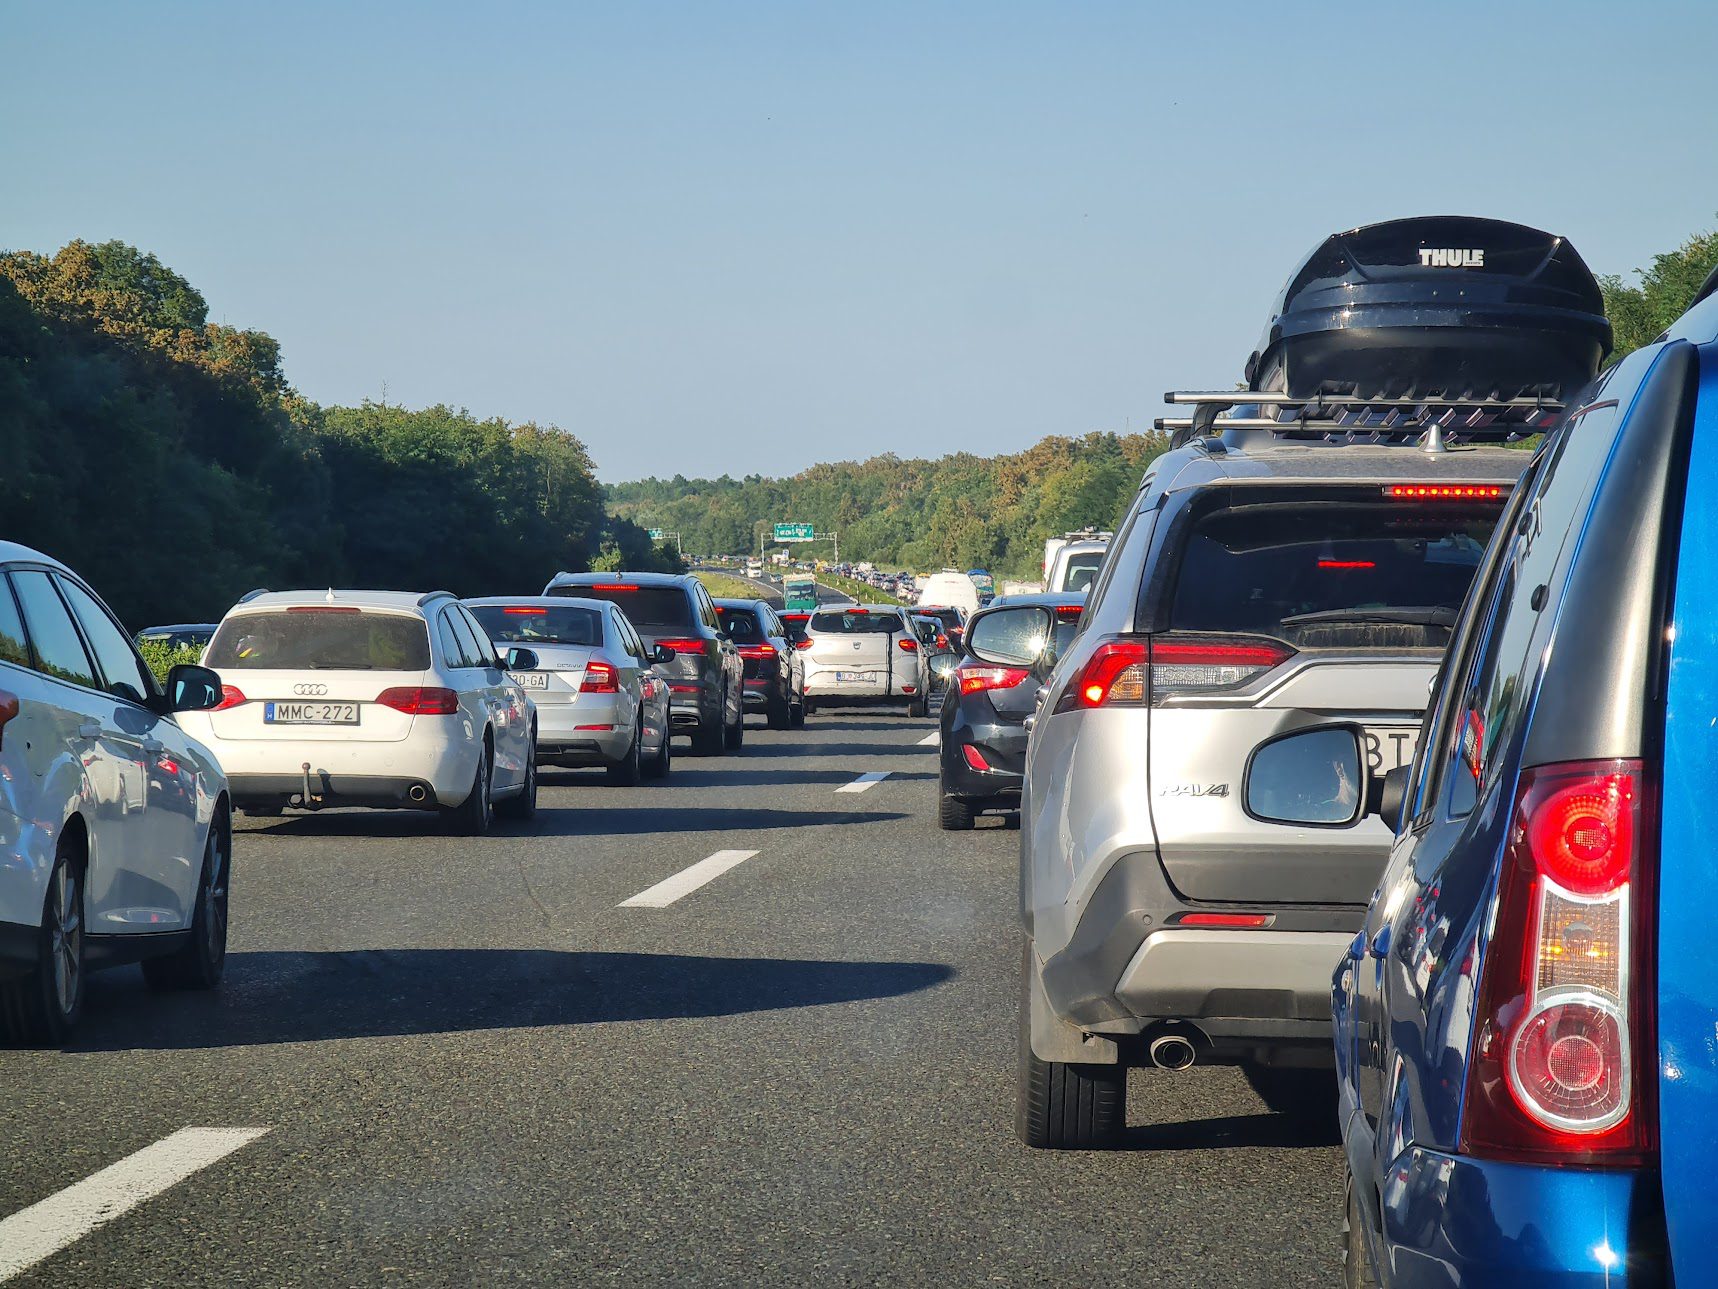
0, 0, 1718, 480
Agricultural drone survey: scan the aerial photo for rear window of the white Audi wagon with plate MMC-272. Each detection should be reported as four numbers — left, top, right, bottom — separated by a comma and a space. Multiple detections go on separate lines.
203, 608, 430, 672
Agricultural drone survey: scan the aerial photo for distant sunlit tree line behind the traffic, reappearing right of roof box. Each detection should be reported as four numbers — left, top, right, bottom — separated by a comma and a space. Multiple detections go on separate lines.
608, 219, 1718, 577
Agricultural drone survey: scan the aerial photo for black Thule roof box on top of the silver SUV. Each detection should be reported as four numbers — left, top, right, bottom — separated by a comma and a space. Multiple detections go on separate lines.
1246, 215, 1611, 402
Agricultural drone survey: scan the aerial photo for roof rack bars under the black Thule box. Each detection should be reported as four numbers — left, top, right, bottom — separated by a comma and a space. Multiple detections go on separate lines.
1153, 390, 1563, 452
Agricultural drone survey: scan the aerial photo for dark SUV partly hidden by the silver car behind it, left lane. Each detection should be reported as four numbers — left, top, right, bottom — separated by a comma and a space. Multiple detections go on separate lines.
543, 572, 746, 756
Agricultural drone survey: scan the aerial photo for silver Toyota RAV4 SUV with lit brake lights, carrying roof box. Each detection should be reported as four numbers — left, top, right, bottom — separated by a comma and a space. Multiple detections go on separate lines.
1010, 409, 1553, 1146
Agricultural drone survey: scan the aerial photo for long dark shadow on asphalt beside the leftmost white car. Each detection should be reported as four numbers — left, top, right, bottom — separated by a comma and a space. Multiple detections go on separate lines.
74, 949, 953, 1052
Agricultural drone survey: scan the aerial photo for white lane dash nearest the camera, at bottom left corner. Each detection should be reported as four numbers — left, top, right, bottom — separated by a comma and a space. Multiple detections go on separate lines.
0, 1127, 270, 1280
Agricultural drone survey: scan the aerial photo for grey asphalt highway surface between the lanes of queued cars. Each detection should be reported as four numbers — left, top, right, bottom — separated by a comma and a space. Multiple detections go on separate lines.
0, 712, 1342, 1286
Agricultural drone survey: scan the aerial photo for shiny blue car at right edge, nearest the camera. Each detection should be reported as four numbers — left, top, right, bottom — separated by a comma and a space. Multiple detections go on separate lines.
1287, 273, 1718, 1289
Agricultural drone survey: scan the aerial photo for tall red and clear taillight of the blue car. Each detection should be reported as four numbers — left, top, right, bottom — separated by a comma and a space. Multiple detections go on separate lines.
1462, 761, 1656, 1164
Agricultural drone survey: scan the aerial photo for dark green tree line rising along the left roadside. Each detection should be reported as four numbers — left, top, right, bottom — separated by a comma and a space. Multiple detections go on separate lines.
0, 241, 675, 627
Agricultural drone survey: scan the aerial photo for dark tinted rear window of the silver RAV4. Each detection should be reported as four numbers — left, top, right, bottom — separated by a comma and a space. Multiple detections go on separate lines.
1170, 502, 1502, 650
